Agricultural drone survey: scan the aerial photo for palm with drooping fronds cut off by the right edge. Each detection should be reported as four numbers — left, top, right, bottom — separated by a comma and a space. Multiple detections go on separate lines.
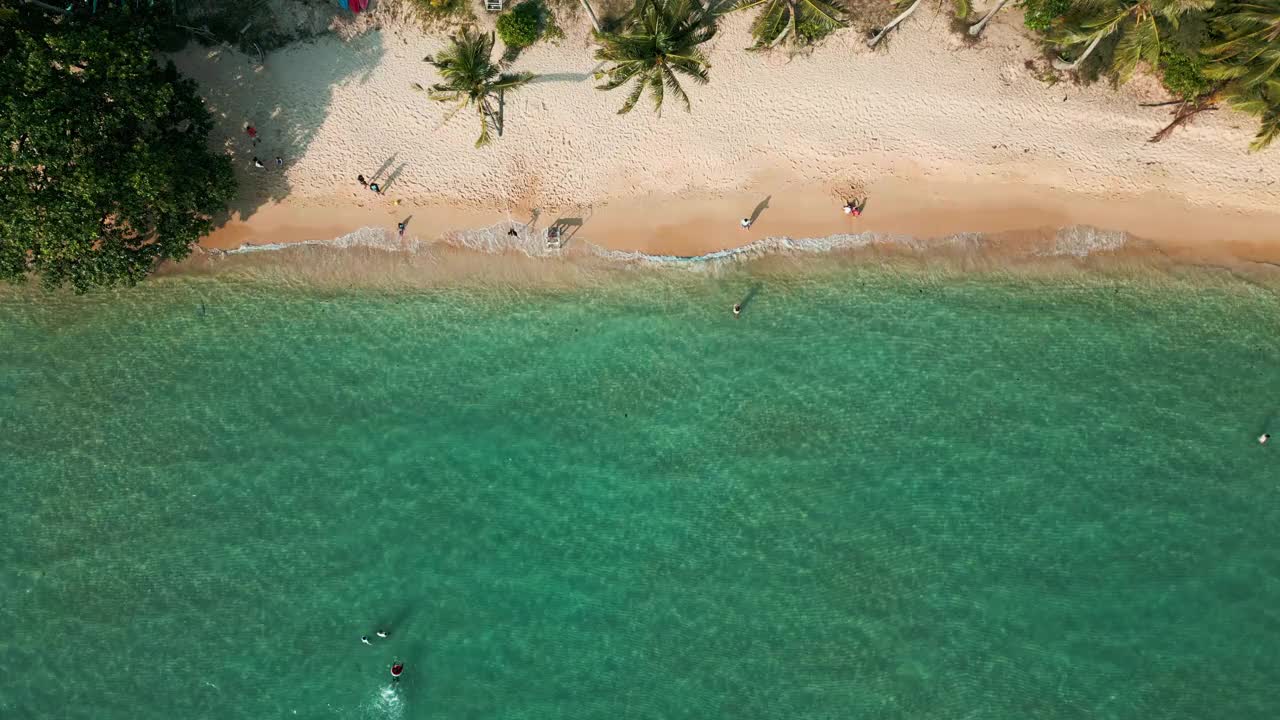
1204, 0, 1280, 151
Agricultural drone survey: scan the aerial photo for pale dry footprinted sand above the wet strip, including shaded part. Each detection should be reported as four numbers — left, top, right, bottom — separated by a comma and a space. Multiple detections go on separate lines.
175, 9, 1280, 252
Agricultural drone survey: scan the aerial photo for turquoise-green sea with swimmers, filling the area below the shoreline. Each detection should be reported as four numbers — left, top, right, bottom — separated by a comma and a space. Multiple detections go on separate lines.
0, 253, 1280, 720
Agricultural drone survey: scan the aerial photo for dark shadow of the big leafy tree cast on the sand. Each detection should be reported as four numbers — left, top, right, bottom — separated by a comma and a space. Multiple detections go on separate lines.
173, 32, 385, 227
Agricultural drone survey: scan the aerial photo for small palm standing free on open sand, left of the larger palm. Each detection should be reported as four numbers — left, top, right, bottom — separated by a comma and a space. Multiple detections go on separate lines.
413, 28, 538, 147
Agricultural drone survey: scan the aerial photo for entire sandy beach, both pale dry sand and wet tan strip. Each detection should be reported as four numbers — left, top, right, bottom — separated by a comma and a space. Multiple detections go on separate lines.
175, 5, 1280, 261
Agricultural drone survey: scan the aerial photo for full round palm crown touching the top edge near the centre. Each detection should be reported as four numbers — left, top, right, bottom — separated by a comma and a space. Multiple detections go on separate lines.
595, 0, 716, 115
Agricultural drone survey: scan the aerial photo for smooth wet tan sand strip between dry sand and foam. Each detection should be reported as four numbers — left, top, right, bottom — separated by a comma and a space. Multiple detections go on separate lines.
201, 179, 1280, 263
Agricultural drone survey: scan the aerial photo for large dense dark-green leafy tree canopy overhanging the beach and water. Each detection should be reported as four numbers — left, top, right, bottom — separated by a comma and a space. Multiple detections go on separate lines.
0, 8, 236, 292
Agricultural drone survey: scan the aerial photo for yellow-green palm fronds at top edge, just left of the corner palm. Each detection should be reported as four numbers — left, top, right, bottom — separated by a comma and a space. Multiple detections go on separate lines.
1053, 0, 1213, 78
